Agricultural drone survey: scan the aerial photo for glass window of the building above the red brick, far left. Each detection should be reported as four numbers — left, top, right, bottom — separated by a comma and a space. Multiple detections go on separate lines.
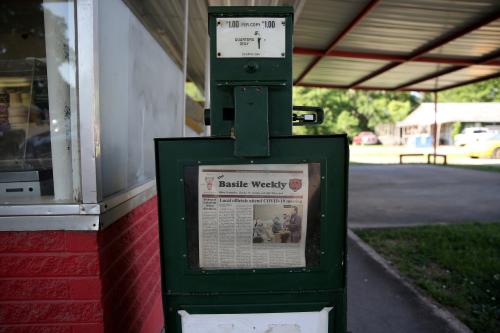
0, 0, 76, 203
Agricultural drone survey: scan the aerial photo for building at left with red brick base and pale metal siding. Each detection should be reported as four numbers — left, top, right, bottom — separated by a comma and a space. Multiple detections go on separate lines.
0, 0, 207, 333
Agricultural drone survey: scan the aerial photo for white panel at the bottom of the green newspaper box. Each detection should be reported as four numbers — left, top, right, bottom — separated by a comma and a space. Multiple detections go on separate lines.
179, 308, 332, 333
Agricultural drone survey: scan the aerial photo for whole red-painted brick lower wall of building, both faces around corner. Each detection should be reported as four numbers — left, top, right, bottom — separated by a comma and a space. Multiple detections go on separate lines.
0, 198, 163, 333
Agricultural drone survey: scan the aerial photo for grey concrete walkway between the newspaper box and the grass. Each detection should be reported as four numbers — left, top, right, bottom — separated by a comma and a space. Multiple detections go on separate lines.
347, 239, 453, 333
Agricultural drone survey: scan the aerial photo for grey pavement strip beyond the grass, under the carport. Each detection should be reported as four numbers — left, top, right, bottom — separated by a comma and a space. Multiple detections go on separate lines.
349, 165, 500, 228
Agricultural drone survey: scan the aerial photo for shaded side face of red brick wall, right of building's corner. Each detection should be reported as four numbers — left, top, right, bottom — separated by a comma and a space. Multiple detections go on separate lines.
99, 198, 163, 333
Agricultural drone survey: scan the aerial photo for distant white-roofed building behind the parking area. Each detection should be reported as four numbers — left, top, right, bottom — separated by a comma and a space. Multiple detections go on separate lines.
375, 103, 500, 145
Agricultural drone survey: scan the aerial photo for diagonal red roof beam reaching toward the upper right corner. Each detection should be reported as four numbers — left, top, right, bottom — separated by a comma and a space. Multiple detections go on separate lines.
349, 10, 500, 88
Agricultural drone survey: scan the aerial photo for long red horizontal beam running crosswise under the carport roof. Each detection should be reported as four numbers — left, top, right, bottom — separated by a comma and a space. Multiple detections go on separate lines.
293, 47, 500, 66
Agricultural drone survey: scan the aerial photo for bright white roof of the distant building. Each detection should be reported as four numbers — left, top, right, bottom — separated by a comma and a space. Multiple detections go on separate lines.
397, 103, 500, 127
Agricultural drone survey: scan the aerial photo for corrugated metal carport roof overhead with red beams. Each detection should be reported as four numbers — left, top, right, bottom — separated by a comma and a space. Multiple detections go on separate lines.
124, 0, 500, 90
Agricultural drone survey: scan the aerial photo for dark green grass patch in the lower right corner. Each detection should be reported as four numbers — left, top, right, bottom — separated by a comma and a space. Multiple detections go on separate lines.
355, 223, 500, 332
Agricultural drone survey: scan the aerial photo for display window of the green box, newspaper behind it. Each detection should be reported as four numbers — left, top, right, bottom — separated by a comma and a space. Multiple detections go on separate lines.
184, 163, 321, 270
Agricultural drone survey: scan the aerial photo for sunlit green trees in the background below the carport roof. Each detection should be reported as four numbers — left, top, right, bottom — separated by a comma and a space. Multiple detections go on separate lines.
293, 79, 500, 139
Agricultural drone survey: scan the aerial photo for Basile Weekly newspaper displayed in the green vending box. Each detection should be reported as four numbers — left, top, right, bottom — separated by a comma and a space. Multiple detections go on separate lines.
198, 164, 309, 269
